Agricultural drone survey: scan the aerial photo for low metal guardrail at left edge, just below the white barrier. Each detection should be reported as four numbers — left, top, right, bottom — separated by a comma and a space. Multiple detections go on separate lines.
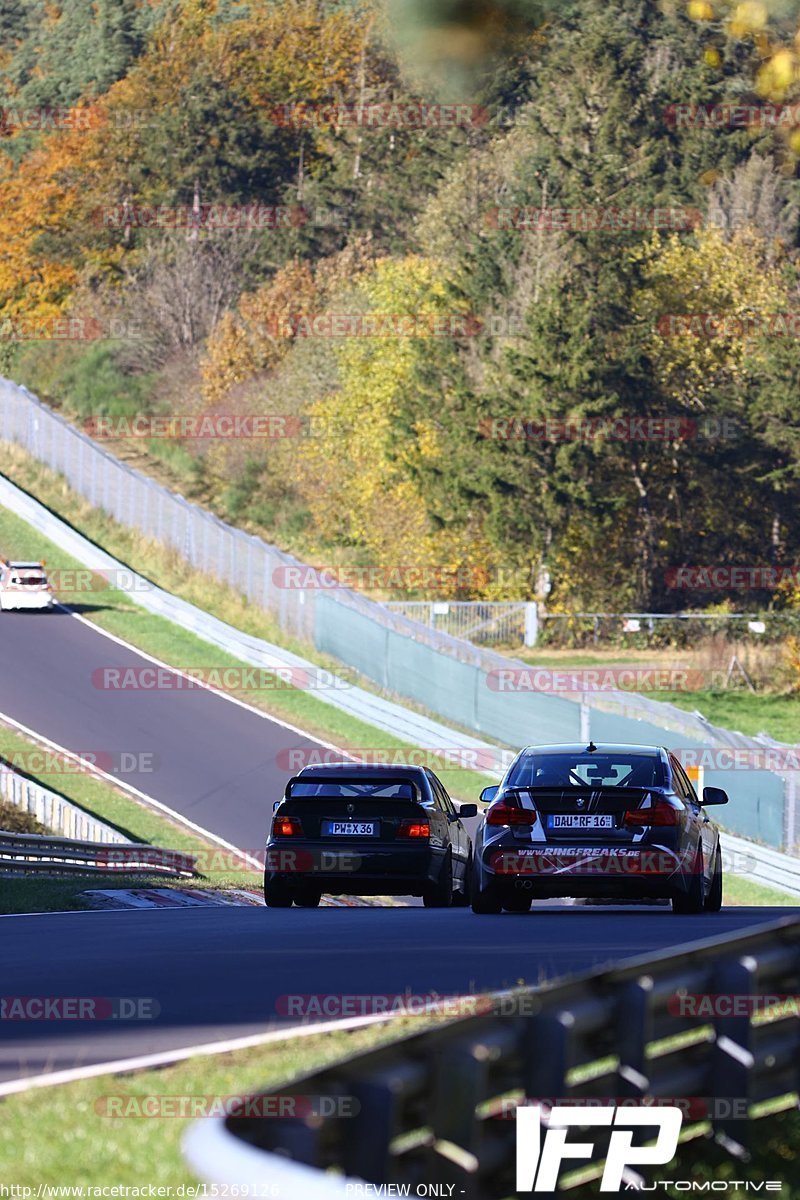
0, 832, 197, 877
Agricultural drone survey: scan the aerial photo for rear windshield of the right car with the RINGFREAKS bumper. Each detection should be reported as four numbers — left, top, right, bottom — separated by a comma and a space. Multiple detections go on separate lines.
506, 751, 667, 787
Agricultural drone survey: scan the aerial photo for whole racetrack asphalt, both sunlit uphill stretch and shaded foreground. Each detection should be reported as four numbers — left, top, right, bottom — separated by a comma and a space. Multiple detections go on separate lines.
0, 612, 786, 1080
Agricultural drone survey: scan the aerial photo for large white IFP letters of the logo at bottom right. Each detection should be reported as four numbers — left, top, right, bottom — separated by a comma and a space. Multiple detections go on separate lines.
517, 1104, 684, 1194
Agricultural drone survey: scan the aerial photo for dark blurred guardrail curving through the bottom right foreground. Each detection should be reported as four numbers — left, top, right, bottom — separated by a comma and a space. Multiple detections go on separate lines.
185, 918, 800, 1200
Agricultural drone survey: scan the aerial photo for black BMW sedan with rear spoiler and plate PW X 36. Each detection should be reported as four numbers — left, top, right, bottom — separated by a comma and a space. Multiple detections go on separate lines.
264, 762, 477, 908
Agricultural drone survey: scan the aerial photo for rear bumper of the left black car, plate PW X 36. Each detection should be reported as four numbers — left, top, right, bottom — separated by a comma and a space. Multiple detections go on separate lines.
264, 839, 446, 895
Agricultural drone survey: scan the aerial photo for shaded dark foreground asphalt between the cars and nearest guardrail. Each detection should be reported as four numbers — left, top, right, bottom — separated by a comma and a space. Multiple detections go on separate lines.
0, 902, 786, 1080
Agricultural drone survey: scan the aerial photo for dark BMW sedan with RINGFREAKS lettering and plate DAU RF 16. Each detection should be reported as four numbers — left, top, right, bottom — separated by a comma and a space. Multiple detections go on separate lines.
471, 742, 728, 913
